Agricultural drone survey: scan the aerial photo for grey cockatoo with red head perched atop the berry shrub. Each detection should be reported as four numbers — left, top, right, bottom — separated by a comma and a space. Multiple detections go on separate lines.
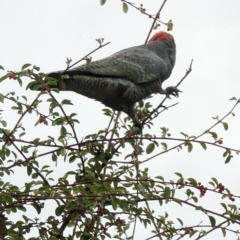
31, 31, 181, 131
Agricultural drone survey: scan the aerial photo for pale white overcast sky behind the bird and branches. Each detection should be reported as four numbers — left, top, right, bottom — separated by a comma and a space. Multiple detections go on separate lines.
0, 0, 240, 239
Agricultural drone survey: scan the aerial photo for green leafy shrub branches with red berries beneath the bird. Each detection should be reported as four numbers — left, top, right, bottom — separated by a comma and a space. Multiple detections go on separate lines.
0, 0, 240, 240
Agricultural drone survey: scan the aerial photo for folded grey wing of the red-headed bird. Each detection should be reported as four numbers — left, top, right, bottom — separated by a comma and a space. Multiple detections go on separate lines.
67, 46, 165, 84
